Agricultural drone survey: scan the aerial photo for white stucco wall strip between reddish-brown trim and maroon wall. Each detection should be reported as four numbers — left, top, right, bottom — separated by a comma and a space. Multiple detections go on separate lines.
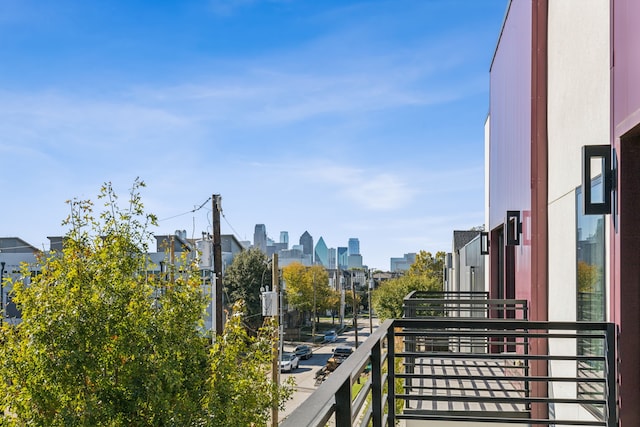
548, 0, 610, 419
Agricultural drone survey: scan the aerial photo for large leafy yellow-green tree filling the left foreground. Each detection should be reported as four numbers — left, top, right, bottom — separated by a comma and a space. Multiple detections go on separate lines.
0, 180, 288, 426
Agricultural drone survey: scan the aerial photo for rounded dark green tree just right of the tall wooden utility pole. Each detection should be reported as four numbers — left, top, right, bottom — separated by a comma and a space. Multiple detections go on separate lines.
224, 248, 271, 329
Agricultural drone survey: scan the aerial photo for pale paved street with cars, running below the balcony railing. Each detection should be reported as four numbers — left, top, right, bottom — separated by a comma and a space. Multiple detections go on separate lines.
278, 319, 378, 421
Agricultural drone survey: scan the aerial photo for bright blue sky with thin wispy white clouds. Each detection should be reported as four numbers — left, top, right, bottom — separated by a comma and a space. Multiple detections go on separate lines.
0, 0, 507, 270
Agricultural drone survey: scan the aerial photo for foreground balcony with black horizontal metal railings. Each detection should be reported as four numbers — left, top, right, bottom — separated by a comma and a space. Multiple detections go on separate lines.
281, 294, 618, 427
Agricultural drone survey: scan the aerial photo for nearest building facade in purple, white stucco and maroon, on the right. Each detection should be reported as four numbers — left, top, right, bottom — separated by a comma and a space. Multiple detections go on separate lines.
485, 0, 640, 427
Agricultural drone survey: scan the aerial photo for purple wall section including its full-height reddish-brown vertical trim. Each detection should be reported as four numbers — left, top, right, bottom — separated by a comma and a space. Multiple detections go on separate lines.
489, 0, 548, 419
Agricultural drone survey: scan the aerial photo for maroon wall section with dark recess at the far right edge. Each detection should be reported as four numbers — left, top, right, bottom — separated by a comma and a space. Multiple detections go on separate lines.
611, 0, 640, 427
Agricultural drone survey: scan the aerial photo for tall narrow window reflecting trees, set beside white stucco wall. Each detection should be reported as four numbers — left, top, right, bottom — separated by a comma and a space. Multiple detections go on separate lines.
576, 176, 606, 412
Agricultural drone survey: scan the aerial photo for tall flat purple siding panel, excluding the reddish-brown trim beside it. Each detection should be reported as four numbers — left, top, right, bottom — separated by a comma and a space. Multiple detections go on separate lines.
489, 1, 532, 300
